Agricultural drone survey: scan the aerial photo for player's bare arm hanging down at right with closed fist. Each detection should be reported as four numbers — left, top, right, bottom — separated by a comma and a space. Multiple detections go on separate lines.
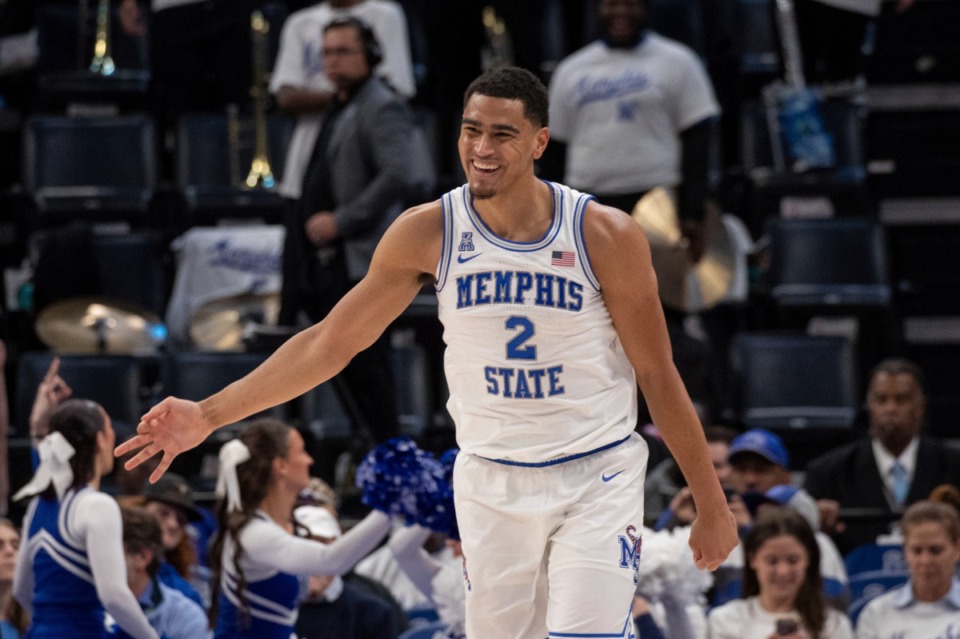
584, 202, 737, 570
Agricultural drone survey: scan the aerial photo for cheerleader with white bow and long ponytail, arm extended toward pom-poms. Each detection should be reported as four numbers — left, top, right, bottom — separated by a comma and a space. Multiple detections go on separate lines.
210, 419, 390, 639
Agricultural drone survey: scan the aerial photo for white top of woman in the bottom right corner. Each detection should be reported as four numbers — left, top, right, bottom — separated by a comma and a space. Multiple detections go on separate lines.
857, 579, 960, 639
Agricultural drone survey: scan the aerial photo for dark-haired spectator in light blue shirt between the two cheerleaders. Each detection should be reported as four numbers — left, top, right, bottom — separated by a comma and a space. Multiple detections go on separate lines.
117, 506, 211, 639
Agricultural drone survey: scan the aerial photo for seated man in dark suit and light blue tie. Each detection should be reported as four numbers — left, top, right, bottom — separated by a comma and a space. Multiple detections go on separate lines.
805, 359, 960, 554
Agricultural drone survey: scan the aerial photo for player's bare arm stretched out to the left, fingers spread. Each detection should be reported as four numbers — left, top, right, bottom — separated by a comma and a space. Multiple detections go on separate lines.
114, 202, 442, 481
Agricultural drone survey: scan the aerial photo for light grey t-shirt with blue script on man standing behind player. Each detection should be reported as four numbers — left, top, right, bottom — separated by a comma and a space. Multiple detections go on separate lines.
550, 33, 720, 195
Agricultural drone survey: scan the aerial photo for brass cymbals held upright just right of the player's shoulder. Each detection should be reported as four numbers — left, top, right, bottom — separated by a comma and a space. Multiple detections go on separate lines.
630, 188, 736, 313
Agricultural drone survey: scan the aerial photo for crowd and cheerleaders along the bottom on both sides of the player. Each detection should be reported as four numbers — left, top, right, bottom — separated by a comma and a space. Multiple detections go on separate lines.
0, 352, 960, 639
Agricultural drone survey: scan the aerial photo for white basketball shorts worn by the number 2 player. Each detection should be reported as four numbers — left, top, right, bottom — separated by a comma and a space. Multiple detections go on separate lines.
454, 433, 647, 639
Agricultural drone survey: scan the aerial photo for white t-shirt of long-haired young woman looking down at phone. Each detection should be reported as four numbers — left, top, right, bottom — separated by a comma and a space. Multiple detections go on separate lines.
707, 597, 853, 639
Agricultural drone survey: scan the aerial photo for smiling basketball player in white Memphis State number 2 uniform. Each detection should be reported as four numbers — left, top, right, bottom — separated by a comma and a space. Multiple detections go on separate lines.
117, 67, 737, 639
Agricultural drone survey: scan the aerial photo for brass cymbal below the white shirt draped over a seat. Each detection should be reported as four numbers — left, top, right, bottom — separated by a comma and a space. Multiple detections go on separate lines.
190, 293, 280, 351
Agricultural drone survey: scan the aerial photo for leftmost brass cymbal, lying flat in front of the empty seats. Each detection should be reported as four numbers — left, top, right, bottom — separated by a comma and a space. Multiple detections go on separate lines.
36, 297, 167, 355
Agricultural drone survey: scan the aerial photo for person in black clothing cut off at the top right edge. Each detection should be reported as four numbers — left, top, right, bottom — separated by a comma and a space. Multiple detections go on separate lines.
795, 0, 914, 84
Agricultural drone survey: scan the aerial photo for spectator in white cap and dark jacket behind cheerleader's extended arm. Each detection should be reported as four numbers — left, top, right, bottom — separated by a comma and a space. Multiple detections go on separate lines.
294, 506, 400, 639
